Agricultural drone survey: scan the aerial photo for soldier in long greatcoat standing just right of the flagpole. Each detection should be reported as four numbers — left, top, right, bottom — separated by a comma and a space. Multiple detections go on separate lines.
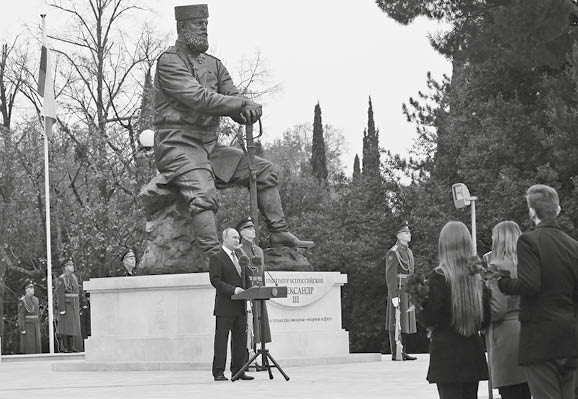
54, 260, 82, 352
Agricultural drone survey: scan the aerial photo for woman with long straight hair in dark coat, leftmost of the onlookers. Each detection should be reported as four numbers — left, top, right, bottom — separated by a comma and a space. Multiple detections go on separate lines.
418, 222, 490, 399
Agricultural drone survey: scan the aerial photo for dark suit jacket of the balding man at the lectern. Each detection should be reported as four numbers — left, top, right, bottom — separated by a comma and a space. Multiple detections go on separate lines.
209, 248, 251, 317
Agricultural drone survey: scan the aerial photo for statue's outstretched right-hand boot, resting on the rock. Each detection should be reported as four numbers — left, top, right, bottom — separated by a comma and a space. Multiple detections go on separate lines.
257, 187, 315, 248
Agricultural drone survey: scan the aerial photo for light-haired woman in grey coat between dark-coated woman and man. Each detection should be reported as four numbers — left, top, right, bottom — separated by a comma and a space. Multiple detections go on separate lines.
486, 221, 531, 399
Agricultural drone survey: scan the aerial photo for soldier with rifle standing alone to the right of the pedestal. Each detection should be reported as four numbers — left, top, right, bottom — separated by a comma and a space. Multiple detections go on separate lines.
385, 222, 417, 360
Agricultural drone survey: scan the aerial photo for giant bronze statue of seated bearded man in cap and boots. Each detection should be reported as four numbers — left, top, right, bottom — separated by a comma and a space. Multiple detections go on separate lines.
151, 4, 313, 257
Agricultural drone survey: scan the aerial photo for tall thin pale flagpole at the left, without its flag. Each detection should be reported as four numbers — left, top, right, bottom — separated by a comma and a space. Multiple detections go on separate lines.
40, 14, 54, 353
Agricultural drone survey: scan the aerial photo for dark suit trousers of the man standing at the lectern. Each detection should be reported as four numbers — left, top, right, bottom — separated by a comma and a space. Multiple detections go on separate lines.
213, 315, 249, 376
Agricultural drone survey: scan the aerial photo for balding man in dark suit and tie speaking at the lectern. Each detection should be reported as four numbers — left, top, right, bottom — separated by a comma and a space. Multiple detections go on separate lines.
209, 228, 254, 381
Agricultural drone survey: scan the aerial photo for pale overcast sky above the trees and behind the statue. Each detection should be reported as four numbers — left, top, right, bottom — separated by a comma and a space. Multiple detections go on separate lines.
0, 0, 451, 171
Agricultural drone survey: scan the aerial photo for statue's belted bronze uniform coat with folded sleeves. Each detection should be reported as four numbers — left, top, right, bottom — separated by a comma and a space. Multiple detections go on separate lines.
153, 41, 244, 187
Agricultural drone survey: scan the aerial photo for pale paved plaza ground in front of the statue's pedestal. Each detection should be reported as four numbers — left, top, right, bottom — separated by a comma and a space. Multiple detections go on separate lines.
0, 354, 496, 399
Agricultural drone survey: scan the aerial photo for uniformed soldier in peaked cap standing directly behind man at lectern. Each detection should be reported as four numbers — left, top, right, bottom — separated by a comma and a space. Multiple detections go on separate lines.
235, 216, 271, 368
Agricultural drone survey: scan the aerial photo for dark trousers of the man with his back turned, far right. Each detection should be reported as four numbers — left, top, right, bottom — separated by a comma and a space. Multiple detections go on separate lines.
524, 359, 576, 399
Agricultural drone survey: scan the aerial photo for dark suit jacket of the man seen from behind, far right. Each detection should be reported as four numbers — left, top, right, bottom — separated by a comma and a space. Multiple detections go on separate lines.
498, 220, 578, 364
